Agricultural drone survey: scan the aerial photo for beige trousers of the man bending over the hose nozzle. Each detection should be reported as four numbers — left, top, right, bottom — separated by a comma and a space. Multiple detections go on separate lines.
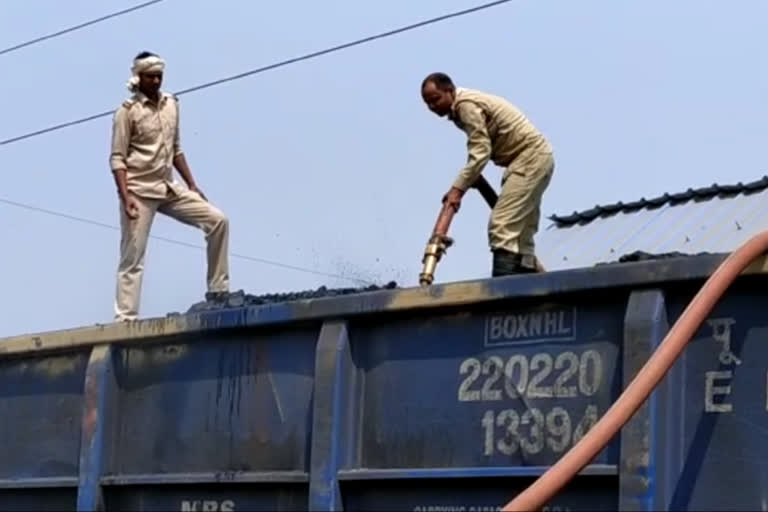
488, 151, 555, 268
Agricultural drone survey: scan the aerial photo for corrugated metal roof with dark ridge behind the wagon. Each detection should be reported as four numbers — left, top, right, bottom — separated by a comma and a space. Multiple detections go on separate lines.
536, 176, 768, 270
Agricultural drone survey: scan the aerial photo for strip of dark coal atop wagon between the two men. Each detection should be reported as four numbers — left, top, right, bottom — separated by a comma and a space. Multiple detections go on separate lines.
187, 281, 397, 313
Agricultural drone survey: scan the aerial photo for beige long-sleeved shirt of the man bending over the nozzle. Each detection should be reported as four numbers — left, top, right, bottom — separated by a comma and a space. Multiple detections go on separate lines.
450, 87, 552, 190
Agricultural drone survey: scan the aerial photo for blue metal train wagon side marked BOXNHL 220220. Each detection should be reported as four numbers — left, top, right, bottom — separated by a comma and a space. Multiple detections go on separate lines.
0, 256, 768, 512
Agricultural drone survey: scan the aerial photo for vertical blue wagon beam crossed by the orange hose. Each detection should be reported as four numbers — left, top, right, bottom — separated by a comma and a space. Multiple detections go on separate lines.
619, 290, 669, 511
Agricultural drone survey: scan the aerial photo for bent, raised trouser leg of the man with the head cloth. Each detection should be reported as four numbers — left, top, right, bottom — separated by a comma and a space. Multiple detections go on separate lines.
158, 190, 229, 296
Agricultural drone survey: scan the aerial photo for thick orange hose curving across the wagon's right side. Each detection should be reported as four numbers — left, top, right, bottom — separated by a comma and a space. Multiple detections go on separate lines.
502, 231, 768, 512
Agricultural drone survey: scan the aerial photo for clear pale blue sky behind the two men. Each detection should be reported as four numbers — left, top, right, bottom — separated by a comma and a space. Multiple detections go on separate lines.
0, 0, 768, 336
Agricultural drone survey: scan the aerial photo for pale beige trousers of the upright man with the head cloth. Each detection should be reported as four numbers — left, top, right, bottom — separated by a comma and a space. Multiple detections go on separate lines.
115, 187, 229, 322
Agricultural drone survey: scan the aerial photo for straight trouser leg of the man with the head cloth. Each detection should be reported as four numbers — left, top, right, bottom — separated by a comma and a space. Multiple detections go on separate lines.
114, 197, 157, 322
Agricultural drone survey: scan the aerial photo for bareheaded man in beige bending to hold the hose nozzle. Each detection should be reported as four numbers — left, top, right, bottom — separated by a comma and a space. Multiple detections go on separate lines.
421, 73, 555, 277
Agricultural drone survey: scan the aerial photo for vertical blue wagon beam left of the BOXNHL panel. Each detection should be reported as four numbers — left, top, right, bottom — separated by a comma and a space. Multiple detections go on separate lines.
309, 321, 359, 511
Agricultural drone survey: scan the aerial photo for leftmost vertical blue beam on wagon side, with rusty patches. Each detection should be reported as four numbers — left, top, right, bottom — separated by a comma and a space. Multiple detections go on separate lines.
77, 345, 117, 512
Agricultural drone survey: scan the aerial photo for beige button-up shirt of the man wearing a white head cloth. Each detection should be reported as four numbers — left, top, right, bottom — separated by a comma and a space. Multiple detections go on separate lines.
110, 92, 182, 198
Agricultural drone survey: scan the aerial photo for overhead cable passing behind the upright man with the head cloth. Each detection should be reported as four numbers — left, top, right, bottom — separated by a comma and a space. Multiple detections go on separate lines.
0, 0, 512, 146
